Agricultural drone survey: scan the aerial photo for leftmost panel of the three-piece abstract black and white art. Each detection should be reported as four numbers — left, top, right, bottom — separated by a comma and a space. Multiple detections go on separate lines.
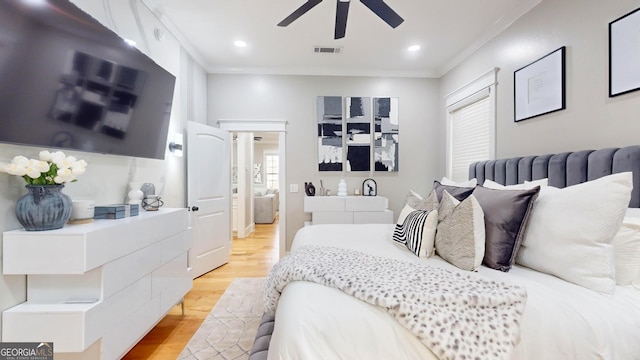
317, 96, 342, 171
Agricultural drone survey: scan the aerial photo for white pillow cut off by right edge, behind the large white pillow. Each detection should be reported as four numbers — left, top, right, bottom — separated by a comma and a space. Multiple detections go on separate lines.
611, 209, 640, 285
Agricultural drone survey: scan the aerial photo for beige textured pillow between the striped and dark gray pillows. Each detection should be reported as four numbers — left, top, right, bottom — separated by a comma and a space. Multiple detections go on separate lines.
435, 190, 485, 271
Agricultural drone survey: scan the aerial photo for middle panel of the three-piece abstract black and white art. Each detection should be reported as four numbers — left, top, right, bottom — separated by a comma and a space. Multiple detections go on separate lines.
344, 97, 371, 171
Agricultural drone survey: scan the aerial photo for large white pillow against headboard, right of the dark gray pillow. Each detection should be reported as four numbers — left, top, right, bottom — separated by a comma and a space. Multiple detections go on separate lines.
516, 172, 633, 294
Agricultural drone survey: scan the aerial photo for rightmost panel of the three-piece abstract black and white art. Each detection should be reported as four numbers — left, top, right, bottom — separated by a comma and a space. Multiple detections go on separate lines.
373, 97, 399, 171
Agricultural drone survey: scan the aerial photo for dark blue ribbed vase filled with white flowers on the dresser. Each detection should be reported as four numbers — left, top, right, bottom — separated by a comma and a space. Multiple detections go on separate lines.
0, 151, 87, 231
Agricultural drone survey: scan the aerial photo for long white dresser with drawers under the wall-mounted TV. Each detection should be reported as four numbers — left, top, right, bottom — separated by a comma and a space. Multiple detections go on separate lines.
2, 209, 193, 360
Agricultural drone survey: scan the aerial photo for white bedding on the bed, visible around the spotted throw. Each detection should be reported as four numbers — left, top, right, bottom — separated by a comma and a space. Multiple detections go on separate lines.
269, 225, 640, 360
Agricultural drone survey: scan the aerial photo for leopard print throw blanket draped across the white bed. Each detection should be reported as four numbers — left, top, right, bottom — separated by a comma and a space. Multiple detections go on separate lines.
264, 246, 527, 360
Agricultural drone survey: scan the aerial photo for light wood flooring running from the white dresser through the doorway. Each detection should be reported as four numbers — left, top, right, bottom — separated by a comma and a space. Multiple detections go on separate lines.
123, 219, 279, 360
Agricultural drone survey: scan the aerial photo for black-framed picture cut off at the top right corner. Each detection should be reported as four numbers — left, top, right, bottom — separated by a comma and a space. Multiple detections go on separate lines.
609, 8, 640, 97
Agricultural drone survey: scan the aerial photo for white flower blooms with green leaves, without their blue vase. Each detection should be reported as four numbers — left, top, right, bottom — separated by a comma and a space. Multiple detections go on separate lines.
0, 150, 87, 185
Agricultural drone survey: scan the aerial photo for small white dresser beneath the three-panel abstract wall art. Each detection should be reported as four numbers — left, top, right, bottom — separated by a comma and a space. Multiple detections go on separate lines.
304, 196, 393, 225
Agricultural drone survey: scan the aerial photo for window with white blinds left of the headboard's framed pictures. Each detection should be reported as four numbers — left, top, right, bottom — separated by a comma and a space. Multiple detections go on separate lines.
446, 69, 497, 181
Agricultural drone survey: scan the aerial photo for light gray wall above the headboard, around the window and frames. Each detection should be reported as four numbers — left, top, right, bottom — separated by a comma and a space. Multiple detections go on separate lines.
438, 0, 640, 171
